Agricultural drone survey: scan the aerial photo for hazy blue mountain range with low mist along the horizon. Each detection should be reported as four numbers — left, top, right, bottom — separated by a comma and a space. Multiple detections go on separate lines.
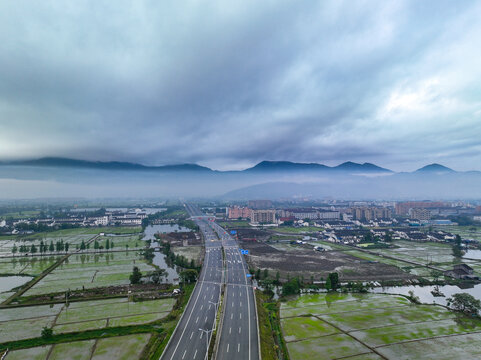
0, 157, 481, 200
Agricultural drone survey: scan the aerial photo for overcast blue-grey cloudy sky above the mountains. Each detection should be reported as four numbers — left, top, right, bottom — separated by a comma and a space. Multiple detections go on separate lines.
0, 0, 481, 170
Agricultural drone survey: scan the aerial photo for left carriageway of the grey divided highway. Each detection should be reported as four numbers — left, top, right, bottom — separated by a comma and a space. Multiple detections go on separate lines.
161, 206, 223, 360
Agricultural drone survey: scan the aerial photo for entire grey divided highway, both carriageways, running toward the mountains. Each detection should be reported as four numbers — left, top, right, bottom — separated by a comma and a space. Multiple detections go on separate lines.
161, 205, 260, 360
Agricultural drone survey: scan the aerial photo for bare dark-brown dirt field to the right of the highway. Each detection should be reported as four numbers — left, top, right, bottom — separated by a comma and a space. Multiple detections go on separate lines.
241, 241, 412, 281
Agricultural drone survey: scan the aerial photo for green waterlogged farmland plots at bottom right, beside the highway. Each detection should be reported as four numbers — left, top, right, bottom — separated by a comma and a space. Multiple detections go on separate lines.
280, 293, 481, 360
